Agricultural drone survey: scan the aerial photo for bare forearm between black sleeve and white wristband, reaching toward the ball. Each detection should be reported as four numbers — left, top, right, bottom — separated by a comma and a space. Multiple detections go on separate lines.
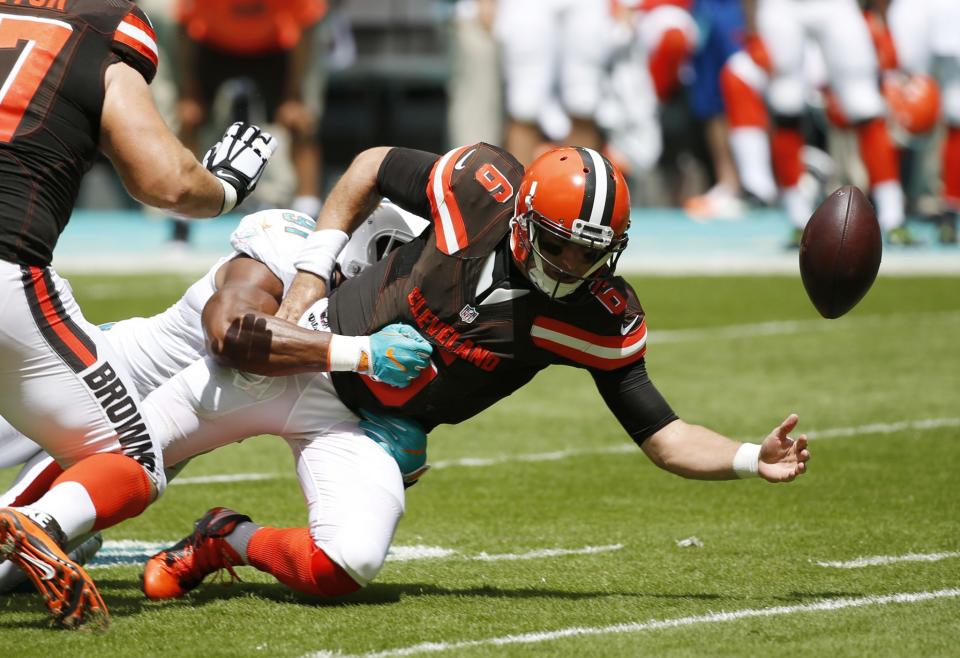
643, 420, 741, 480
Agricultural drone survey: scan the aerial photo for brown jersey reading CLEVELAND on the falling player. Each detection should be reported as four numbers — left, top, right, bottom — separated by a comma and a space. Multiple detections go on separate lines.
328, 144, 647, 436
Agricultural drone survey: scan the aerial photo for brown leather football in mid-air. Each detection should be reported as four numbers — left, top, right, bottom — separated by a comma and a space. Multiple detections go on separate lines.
800, 185, 883, 319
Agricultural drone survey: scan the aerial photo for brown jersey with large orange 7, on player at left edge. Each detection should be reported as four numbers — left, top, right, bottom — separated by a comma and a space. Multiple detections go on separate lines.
0, 0, 157, 267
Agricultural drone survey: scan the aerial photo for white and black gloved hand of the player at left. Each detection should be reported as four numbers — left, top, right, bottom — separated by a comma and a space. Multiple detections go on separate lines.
203, 121, 277, 213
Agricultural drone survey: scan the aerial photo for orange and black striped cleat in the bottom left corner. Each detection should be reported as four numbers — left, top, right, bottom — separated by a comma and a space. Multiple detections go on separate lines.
0, 507, 110, 628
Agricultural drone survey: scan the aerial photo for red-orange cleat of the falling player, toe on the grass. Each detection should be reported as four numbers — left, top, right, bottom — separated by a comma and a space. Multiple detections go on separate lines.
143, 507, 250, 600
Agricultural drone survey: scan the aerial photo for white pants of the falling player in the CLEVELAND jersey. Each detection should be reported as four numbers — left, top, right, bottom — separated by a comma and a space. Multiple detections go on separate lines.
144, 348, 404, 585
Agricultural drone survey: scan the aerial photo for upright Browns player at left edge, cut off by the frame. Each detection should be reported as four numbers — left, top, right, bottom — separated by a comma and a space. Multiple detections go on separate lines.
0, 0, 275, 627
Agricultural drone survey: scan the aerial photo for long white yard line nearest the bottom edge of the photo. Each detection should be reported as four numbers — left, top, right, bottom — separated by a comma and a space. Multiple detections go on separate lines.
304, 589, 960, 658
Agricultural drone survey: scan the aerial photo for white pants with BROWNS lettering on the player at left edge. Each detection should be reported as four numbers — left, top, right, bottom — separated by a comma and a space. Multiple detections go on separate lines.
0, 261, 166, 495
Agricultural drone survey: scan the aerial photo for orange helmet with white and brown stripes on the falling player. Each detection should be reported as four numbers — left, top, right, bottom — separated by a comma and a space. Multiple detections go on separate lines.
510, 147, 630, 298
